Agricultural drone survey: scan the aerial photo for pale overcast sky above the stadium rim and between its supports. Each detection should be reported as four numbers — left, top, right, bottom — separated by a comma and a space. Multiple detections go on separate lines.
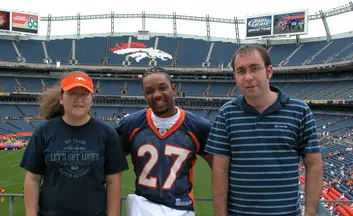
0, 0, 353, 38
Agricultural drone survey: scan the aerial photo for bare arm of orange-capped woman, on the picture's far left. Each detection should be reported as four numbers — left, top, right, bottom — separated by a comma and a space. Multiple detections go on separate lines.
24, 171, 42, 216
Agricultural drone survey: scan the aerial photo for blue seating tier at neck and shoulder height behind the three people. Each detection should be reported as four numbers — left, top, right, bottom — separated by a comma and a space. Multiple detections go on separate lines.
0, 104, 353, 136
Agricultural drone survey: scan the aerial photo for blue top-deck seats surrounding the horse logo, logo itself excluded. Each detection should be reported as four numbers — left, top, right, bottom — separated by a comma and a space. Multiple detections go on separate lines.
0, 35, 353, 68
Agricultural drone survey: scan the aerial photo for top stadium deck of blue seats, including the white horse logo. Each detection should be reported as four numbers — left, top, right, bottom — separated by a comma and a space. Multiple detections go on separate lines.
0, 34, 353, 69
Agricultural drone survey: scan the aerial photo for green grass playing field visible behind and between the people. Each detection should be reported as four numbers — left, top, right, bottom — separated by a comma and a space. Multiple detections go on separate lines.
0, 149, 213, 216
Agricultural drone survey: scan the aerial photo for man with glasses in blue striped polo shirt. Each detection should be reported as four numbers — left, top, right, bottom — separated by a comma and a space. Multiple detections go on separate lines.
205, 45, 323, 216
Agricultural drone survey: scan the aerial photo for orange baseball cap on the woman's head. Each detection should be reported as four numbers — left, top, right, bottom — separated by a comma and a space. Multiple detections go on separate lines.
61, 73, 93, 93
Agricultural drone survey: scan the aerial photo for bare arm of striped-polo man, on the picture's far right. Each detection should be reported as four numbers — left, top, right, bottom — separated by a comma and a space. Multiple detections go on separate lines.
303, 153, 323, 216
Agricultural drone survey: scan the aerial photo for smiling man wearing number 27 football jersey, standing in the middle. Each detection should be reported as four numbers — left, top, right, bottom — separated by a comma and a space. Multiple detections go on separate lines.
116, 68, 212, 216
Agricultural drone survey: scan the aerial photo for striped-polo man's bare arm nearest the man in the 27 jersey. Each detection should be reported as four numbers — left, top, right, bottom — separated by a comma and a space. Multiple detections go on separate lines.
212, 155, 230, 216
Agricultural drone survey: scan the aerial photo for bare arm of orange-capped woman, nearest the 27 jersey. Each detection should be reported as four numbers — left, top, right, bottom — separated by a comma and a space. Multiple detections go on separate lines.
106, 173, 121, 216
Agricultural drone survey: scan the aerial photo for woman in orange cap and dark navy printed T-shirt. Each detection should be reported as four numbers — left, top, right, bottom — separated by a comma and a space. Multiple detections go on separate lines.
20, 72, 128, 216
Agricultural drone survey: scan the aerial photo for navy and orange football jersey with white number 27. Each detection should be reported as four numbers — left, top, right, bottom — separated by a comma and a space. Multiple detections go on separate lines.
116, 108, 211, 211
